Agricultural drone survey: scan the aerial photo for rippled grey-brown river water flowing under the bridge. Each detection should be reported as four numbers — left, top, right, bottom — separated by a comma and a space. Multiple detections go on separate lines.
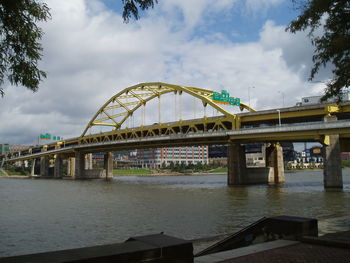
0, 170, 350, 257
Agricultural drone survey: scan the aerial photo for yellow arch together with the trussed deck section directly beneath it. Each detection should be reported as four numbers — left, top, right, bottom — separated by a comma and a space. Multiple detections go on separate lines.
79, 82, 255, 144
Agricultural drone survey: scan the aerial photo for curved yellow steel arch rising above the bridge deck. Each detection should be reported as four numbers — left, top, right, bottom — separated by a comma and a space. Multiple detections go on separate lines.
81, 82, 255, 137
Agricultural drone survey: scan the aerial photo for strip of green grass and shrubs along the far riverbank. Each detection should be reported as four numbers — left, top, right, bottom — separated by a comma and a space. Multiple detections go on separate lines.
0, 160, 350, 178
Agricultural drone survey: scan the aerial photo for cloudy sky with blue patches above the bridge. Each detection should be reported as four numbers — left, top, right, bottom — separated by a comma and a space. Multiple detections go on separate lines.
0, 0, 328, 144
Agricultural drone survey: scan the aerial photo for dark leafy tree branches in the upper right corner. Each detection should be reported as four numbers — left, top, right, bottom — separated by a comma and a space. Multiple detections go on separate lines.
286, 0, 350, 101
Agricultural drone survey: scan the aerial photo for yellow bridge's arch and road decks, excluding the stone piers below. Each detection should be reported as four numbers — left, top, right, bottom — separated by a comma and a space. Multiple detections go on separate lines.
0, 82, 350, 161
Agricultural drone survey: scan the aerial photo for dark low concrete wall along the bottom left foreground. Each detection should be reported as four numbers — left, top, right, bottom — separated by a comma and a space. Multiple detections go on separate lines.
0, 234, 193, 263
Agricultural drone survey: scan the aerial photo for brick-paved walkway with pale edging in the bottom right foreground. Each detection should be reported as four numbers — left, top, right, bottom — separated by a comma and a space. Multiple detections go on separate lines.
194, 231, 350, 263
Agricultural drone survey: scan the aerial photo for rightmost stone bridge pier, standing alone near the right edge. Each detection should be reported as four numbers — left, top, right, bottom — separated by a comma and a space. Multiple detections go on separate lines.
323, 134, 343, 189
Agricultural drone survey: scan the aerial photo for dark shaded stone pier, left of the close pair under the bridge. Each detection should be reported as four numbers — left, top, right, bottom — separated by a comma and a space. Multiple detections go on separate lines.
227, 143, 247, 185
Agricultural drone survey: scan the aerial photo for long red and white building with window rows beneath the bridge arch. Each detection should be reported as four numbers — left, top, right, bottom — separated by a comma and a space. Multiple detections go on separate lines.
136, 146, 208, 168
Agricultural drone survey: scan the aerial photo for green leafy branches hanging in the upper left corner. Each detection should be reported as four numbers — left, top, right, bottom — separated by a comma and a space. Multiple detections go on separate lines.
0, 0, 50, 96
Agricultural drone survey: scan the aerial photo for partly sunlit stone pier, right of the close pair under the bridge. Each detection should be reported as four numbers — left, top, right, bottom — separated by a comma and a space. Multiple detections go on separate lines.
265, 144, 285, 184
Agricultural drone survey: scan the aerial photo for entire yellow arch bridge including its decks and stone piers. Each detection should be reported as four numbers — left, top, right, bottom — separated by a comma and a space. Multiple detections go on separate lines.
0, 82, 350, 188
